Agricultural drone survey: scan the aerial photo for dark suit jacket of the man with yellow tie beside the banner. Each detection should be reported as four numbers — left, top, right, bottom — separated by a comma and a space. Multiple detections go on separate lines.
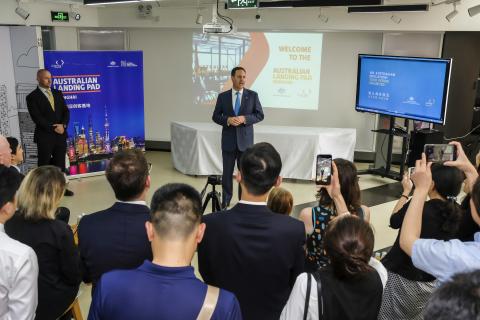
27, 87, 70, 142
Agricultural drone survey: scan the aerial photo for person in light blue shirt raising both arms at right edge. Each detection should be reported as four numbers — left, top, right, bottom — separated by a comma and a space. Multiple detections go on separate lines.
400, 142, 480, 282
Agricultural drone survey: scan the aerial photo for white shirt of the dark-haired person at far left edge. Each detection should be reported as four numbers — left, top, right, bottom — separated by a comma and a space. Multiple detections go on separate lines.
0, 223, 38, 320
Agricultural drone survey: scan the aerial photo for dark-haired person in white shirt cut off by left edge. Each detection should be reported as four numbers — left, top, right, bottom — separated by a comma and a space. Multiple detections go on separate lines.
0, 165, 38, 320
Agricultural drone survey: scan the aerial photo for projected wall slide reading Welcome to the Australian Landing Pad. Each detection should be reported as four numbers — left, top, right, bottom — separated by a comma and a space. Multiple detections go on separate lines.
192, 32, 323, 110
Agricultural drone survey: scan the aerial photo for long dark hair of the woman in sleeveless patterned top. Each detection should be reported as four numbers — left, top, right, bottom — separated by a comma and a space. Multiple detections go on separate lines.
317, 158, 361, 215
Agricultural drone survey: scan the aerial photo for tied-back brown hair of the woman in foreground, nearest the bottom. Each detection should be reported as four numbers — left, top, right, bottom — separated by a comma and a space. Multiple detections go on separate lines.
324, 215, 375, 279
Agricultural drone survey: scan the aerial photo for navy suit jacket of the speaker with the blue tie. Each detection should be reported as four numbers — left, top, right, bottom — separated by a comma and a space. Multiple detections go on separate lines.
212, 88, 264, 151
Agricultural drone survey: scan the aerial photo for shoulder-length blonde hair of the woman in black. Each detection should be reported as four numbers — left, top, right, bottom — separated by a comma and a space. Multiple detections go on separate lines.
17, 166, 65, 220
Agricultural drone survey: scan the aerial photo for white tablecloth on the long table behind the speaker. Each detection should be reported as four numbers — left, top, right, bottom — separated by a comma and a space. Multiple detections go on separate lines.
170, 122, 356, 180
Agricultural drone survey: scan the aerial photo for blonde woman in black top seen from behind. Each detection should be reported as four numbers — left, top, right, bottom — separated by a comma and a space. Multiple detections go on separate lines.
5, 166, 81, 320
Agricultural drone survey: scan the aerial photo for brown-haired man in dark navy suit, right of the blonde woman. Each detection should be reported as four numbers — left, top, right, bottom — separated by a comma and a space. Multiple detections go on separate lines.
78, 150, 152, 287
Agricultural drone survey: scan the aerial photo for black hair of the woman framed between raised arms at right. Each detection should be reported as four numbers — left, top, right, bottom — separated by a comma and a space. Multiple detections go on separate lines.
432, 163, 465, 235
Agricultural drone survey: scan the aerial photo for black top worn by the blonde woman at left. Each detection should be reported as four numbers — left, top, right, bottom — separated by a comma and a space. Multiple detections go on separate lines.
4, 214, 82, 320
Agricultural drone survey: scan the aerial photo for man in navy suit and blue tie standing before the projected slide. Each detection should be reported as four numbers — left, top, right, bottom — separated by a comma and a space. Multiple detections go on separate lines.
212, 67, 264, 208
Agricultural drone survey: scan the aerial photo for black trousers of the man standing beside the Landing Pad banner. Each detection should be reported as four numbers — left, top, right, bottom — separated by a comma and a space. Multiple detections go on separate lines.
37, 136, 67, 172
